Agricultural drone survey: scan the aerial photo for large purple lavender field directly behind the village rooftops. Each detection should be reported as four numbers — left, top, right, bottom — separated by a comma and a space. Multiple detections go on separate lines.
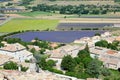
10, 31, 105, 43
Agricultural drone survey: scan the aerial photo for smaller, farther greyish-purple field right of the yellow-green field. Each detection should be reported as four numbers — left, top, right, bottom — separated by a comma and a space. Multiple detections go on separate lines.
57, 23, 114, 30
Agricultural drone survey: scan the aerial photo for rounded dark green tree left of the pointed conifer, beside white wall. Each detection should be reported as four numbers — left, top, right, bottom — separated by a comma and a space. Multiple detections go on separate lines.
61, 55, 77, 71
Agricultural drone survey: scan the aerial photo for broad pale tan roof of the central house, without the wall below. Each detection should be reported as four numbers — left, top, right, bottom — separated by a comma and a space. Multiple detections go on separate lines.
48, 45, 85, 59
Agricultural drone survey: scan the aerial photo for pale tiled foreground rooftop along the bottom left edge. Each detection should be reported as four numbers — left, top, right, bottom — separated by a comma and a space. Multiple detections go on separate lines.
0, 70, 83, 80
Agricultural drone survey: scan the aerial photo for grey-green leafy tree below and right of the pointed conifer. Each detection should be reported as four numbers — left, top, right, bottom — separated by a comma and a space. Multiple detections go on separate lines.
86, 59, 102, 78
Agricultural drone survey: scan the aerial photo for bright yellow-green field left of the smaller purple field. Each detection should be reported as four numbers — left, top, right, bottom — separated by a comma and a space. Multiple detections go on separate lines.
0, 19, 59, 32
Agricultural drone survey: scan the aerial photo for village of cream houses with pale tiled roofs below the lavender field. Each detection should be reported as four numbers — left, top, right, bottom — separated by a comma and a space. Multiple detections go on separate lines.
0, 32, 120, 80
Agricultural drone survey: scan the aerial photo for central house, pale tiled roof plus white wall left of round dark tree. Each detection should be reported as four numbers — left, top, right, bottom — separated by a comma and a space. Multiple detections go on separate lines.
46, 45, 85, 70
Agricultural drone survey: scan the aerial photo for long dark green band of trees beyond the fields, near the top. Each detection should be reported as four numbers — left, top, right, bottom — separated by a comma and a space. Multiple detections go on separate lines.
32, 4, 120, 15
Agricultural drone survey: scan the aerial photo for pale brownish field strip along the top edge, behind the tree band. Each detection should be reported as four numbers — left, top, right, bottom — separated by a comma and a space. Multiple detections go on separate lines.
33, 0, 116, 5
